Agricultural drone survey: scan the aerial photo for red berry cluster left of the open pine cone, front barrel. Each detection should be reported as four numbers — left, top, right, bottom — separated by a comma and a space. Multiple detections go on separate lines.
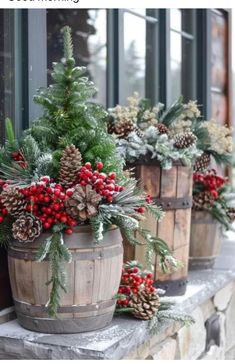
20, 177, 77, 234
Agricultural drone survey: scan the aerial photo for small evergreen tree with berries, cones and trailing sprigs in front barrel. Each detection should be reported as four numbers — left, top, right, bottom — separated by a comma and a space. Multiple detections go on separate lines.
0, 27, 178, 317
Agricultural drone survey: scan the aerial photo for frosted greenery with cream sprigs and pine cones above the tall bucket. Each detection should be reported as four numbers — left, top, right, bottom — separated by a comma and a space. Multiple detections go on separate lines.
107, 93, 232, 171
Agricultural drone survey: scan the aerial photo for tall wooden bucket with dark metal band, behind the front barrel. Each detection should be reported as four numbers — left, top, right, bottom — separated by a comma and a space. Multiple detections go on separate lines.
124, 161, 193, 296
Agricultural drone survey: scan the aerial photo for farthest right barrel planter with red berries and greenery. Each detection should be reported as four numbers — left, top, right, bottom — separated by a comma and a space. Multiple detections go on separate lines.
189, 170, 235, 269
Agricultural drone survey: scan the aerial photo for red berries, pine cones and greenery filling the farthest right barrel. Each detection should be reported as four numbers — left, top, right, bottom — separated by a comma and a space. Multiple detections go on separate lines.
193, 169, 235, 230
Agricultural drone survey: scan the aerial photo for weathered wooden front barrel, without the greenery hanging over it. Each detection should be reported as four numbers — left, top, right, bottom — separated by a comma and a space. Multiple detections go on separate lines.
8, 226, 123, 333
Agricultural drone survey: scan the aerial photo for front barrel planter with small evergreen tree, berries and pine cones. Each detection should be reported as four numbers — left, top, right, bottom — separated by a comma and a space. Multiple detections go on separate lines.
0, 27, 177, 333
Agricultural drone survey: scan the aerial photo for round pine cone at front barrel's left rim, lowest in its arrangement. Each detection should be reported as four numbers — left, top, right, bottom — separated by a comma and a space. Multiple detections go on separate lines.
12, 214, 42, 243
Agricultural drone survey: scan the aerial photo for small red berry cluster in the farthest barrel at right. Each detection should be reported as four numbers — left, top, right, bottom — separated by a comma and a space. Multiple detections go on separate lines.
193, 169, 227, 200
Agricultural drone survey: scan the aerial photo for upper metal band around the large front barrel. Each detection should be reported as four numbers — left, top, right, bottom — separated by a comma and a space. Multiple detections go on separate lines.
8, 246, 123, 261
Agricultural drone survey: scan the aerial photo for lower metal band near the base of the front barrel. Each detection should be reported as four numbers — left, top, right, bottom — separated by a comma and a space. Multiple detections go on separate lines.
14, 300, 115, 314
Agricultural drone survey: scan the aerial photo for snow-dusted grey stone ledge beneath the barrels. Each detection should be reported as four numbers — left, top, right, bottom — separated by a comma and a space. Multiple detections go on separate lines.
0, 242, 235, 359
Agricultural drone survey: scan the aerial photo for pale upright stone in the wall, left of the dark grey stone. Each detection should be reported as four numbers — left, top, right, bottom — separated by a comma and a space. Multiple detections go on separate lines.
176, 307, 206, 360
